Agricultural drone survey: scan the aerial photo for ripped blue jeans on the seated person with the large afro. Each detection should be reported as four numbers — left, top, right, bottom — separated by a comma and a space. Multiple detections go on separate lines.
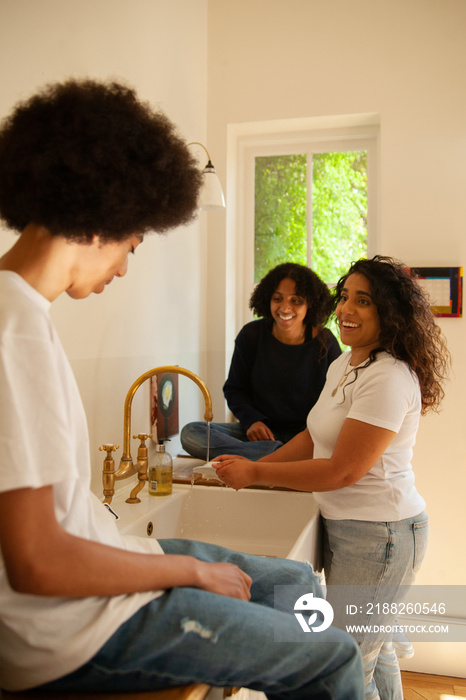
40, 540, 364, 700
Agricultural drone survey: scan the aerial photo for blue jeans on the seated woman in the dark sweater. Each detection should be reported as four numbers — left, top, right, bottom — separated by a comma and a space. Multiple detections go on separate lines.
180, 421, 293, 460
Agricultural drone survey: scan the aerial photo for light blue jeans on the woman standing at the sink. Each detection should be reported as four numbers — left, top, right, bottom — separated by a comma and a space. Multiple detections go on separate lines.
322, 512, 429, 700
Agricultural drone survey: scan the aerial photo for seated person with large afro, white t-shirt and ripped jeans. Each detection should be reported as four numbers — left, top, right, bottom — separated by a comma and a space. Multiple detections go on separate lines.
0, 80, 363, 700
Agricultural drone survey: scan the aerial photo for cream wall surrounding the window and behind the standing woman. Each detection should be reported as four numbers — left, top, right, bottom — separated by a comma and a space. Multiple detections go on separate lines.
208, 0, 466, 675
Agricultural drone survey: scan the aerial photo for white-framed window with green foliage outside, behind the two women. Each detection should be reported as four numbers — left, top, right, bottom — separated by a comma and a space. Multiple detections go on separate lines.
227, 114, 379, 336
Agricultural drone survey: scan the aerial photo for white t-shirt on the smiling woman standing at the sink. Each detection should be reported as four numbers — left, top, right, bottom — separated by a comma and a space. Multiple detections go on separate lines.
307, 352, 425, 521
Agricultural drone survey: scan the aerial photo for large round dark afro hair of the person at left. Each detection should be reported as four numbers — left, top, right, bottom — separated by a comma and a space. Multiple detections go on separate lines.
0, 80, 202, 241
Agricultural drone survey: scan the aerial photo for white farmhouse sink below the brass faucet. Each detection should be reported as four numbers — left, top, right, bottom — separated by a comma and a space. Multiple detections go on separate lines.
111, 484, 320, 569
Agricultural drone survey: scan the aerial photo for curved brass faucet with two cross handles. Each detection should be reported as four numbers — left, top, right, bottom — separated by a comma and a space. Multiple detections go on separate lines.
99, 366, 213, 503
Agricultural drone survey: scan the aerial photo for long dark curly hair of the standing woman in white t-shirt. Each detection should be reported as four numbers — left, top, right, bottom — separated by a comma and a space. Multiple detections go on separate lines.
334, 255, 451, 413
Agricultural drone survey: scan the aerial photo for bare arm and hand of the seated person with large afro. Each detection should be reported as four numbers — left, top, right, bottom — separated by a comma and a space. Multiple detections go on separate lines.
0, 486, 255, 600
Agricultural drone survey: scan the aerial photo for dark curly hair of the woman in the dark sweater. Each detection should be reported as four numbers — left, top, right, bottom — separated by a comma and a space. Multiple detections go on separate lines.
249, 262, 333, 328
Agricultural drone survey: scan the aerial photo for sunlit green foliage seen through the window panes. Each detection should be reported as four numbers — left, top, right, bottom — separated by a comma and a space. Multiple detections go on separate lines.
254, 151, 367, 284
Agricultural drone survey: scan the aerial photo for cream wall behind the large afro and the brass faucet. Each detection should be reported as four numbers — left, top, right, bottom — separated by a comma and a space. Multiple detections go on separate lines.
0, 0, 207, 493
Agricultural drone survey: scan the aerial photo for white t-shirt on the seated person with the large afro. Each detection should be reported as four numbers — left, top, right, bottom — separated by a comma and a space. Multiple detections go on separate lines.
0, 271, 167, 690
